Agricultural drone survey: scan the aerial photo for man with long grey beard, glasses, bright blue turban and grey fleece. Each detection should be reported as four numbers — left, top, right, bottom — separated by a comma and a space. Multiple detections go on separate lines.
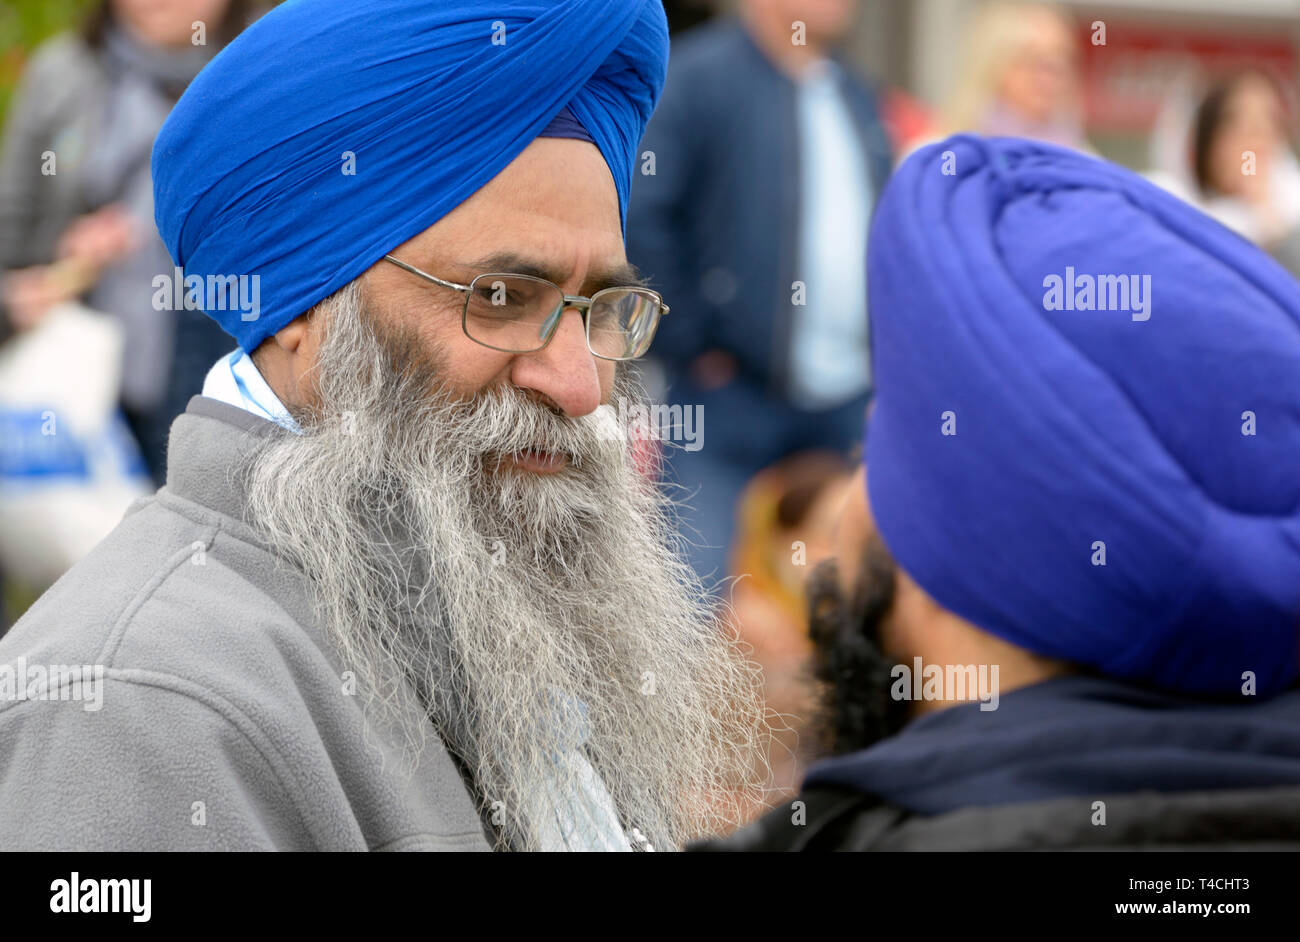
0, 0, 764, 850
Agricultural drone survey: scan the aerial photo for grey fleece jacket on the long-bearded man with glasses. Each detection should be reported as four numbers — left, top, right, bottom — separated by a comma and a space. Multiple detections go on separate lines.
0, 396, 489, 850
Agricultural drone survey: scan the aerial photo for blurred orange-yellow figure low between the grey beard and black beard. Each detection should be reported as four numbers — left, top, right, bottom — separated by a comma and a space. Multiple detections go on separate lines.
731, 452, 853, 800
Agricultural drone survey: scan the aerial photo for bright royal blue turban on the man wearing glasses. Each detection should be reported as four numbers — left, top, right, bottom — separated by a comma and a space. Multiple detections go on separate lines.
153, 0, 668, 350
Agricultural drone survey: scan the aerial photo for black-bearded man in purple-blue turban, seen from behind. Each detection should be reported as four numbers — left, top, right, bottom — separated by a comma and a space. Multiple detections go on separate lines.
702, 136, 1300, 850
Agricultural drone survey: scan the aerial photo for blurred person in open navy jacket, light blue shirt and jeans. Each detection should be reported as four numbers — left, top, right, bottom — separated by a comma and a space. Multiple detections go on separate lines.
628, 0, 891, 585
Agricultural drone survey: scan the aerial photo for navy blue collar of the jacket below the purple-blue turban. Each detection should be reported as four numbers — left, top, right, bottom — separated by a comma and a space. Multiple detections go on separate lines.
803, 674, 1300, 815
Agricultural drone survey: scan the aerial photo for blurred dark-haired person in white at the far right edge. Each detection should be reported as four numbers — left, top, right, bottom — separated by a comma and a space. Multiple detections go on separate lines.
1149, 69, 1300, 274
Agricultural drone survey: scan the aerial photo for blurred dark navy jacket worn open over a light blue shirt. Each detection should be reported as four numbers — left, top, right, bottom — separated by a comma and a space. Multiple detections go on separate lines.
628, 18, 891, 400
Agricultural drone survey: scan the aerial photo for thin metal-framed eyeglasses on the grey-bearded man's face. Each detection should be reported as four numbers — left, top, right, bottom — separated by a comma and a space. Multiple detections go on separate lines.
384, 255, 668, 360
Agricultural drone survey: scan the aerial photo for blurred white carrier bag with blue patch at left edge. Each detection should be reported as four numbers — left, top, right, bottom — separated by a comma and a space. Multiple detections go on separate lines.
0, 303, 153, 589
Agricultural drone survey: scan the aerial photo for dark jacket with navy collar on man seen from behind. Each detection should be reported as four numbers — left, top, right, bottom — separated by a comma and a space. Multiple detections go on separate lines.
702, 676, 1300, 851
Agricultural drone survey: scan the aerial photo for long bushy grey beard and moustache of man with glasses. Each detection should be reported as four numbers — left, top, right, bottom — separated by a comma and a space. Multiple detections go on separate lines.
246, 282, 768, 850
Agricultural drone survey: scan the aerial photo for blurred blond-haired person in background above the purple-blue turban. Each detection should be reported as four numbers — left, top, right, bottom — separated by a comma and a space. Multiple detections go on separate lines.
940, 0, 1089, 149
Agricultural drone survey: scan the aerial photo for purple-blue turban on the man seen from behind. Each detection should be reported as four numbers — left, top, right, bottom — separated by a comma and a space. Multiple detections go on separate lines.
866, 136, 1300, 695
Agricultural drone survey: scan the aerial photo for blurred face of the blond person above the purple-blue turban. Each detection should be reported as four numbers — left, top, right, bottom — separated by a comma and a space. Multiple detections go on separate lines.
997, 8, 1078, 123
